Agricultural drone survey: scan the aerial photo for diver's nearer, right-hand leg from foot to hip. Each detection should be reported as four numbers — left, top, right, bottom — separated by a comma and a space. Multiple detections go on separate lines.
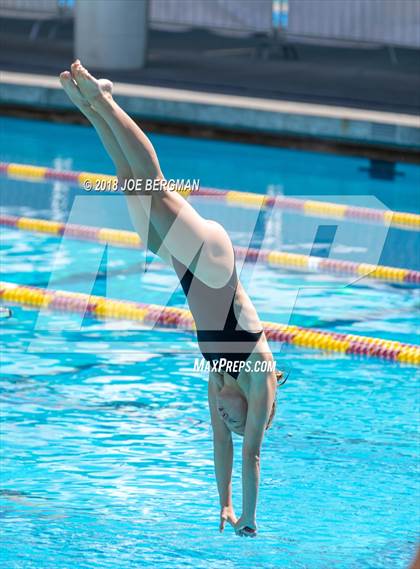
72, 64, 234, 286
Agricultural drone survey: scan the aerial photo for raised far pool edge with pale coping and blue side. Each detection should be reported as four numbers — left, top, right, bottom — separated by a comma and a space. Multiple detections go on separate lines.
0, 70, 420, 150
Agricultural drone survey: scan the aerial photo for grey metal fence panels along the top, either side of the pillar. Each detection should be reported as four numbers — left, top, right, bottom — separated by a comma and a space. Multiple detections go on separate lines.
0, 0, 420, 48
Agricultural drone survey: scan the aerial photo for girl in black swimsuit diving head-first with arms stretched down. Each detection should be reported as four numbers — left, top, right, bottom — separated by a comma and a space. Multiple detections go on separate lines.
60, 60, 281, 537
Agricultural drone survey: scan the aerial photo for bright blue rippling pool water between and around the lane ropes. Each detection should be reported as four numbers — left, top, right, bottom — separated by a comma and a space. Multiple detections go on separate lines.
0, 118, 420, 569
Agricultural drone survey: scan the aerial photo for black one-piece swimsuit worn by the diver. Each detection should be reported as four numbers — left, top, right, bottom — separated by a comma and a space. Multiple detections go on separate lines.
172, 249, 263, 379
